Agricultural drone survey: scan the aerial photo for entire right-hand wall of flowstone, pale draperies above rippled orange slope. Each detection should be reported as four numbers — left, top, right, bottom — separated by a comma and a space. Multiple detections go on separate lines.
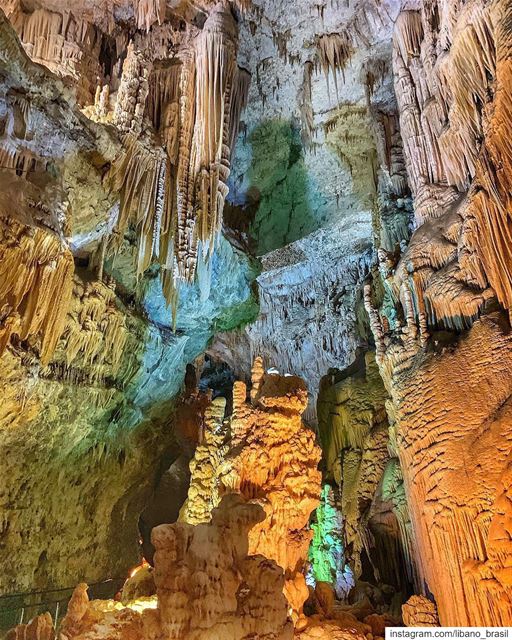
366, 0, 512, 626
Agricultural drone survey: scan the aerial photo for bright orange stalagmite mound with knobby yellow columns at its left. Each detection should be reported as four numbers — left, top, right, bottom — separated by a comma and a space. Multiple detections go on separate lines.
182, 358, 321, 622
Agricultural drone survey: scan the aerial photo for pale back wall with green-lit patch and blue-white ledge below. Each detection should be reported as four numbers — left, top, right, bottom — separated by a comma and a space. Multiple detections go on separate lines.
209, 0, 411, 425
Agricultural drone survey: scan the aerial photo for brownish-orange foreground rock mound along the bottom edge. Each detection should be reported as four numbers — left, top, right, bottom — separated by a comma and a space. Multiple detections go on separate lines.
54, 495, 293, 640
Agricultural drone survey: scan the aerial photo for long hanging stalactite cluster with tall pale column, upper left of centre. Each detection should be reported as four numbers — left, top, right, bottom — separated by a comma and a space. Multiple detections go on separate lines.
110, 3, 250, 316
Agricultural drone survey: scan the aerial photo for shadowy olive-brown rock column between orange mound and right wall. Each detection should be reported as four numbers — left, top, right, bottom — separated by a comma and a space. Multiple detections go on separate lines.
318, 352, 414, 594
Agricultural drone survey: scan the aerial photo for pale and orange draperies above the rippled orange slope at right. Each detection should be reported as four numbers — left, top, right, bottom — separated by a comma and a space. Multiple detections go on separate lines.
367, 0, 512, 359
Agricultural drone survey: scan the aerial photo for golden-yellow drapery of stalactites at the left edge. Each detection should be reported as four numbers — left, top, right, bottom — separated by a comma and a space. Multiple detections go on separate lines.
0, 219, 74, 365
